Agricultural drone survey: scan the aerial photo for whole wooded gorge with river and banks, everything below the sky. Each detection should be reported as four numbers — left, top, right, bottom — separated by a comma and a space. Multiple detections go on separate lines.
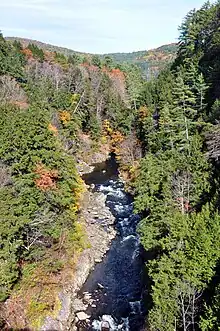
0, 1, 220, 331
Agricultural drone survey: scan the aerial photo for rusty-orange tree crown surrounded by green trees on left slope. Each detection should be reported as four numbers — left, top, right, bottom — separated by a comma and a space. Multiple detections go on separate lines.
35, 164, 58, 191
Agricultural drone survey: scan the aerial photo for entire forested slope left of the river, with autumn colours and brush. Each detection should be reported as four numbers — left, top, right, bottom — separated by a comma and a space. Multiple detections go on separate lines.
0, 35, 142, 329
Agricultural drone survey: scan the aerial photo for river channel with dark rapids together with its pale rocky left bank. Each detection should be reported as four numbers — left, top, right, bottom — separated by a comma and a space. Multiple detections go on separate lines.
41, 157, 145, 331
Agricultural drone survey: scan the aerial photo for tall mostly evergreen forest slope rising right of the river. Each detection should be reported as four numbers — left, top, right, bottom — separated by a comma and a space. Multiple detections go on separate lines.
136, 2, 220, 331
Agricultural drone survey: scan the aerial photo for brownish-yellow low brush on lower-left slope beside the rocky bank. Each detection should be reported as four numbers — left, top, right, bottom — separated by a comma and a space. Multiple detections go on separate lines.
5, 223, 88, 330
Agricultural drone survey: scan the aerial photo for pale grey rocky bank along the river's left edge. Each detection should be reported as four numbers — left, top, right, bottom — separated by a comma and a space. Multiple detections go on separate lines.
41, 167, 116, 331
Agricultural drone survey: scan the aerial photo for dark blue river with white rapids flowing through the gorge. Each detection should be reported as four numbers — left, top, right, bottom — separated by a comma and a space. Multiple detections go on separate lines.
79, 158, 144, 331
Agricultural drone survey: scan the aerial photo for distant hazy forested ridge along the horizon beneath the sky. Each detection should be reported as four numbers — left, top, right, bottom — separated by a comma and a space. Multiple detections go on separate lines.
6, 37, 177, 78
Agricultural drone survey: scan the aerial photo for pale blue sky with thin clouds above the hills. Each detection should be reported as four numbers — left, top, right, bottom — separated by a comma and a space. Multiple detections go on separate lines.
0, 0, 211, 53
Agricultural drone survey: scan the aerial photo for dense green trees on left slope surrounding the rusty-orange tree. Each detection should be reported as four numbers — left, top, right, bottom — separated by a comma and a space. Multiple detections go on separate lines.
0, 104, 81, 298
